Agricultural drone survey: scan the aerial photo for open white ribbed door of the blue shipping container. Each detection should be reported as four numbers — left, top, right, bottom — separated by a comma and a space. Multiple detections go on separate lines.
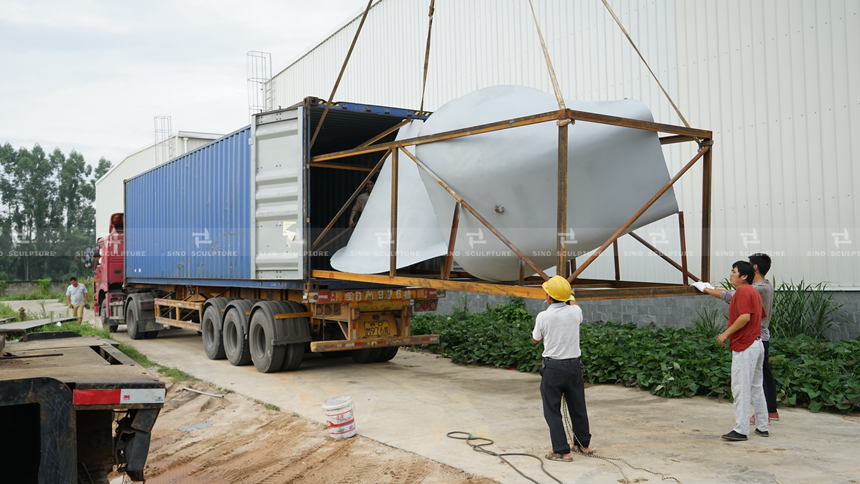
251, 108, 305, 280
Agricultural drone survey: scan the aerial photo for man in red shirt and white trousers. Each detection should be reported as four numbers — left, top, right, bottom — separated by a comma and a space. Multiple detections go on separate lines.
717, 261, 769, 441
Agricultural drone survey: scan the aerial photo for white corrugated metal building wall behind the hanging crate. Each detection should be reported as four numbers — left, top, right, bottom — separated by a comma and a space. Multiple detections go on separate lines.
272, 0, 860, 288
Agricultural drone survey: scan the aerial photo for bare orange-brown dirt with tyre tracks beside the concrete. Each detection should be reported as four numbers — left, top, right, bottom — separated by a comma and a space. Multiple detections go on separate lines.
111, 381, 497, 484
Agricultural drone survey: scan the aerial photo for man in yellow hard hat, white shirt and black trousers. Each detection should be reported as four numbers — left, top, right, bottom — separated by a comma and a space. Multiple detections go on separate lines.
532, 276, 593, 462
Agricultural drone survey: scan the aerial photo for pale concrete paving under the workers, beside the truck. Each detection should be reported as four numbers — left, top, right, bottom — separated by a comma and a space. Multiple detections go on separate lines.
3, 303, 860, 484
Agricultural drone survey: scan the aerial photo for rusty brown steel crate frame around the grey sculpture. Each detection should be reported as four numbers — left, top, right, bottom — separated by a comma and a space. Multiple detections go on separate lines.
307, 109, 714, 300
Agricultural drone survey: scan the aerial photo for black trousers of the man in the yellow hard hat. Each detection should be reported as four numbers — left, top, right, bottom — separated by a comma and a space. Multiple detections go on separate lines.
540, 358, 591, 454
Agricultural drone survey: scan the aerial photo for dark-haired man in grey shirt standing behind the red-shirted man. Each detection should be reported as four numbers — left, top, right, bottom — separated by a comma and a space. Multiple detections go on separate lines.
693, 254, 779, 423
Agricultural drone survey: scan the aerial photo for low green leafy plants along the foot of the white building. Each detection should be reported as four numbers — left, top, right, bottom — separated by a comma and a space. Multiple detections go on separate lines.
412, 300, 860, 412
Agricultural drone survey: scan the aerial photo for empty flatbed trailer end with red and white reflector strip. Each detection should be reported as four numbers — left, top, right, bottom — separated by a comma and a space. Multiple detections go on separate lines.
0, 326, 165, 484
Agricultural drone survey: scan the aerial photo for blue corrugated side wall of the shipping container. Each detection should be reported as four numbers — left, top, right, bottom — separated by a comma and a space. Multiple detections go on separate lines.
125, 127, 253, 282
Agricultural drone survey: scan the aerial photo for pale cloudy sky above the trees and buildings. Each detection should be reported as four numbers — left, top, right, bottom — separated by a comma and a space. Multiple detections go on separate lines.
0, 0, 366, 165
